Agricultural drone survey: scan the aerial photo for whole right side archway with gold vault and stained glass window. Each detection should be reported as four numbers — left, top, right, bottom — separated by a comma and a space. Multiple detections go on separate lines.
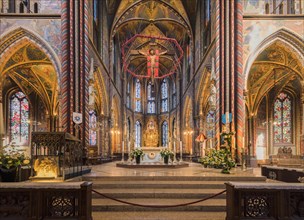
245, 38, 304, 163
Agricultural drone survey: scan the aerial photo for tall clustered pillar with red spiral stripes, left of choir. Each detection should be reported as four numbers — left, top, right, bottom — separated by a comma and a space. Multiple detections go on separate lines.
60, 0, 90, 146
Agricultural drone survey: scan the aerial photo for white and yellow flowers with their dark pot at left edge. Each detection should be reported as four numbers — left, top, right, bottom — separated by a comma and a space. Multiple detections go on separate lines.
0, 145, 30, 182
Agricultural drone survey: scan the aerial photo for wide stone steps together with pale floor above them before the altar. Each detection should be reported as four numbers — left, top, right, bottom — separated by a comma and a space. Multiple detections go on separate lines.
84, 161, 265, 220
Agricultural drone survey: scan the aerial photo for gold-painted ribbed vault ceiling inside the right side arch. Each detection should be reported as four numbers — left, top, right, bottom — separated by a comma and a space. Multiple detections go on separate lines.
248, 41, 304, 112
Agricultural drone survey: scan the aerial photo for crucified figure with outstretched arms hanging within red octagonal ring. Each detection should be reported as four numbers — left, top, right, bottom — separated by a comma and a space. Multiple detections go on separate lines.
138, 49, 168, 85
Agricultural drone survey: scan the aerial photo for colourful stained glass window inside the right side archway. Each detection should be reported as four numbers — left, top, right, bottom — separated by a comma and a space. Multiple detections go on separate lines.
273, 92, 292, 143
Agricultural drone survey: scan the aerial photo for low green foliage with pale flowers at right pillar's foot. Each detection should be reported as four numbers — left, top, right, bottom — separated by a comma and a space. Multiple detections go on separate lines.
199, 148, 235, 173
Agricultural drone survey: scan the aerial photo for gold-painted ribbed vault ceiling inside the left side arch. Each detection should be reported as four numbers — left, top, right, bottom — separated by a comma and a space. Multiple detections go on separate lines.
0, 42, 57, 116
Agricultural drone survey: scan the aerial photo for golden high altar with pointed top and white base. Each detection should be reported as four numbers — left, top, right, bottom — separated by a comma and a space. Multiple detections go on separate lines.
141, 117, 166, 162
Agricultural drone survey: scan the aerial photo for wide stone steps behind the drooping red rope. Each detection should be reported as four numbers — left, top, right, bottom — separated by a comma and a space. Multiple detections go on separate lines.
83, 175, 266, 220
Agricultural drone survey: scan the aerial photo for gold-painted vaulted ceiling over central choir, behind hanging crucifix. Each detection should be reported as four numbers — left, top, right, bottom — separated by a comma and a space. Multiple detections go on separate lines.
111, 0, 192, 80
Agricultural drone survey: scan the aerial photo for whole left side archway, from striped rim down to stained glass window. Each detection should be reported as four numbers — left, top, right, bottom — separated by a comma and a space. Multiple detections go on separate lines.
0, 28, 59, 150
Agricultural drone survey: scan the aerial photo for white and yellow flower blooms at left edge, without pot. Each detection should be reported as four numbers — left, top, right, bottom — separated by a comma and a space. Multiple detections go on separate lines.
0, 144, 30, 170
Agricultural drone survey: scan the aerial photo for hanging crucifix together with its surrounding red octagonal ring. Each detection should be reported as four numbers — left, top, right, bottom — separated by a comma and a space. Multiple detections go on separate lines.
121, 34, 183, 84
